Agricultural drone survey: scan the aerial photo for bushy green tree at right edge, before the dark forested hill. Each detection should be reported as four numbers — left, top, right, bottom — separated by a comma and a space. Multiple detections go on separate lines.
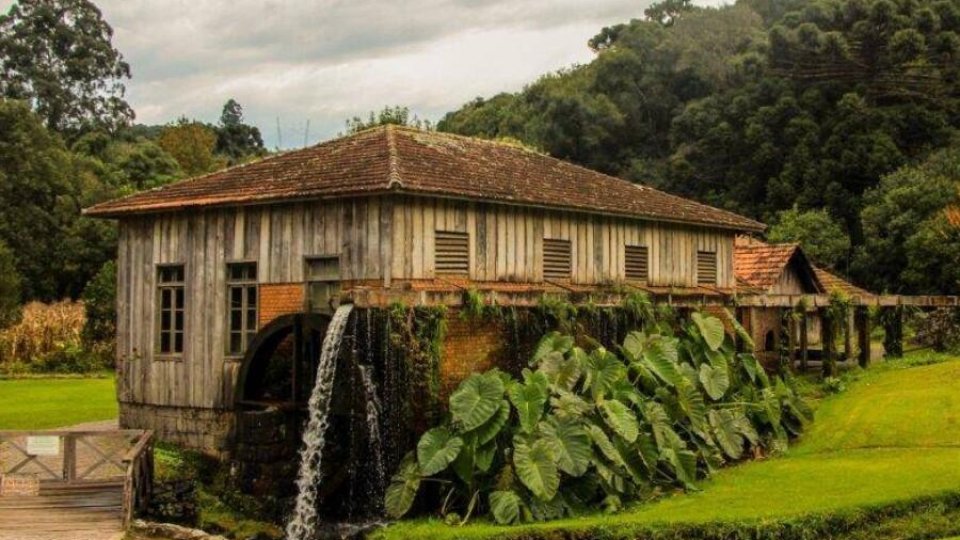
853, 146, 960, 294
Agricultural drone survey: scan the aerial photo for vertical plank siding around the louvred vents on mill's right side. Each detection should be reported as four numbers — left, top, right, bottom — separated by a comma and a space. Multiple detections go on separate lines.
390, 197, 734, 288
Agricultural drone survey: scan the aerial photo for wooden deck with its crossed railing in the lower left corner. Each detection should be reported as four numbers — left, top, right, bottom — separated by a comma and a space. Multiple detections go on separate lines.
0, 430, 153, 540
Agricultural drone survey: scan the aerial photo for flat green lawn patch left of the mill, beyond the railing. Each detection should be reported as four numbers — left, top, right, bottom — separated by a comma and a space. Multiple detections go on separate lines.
0, 377, 117, 429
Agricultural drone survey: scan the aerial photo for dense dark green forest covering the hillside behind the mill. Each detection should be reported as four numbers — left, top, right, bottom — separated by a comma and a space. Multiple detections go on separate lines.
437, 0, 960, 292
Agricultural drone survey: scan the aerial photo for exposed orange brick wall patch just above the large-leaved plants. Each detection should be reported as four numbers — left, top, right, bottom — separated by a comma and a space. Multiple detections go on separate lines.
440, 310, 504, 400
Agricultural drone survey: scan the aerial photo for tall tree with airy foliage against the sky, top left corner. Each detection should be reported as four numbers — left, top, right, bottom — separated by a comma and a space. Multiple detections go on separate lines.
0, 0, 133, 134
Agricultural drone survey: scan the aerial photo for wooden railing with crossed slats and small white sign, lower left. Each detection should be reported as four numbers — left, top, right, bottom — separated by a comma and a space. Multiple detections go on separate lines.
0, 430, 153, 527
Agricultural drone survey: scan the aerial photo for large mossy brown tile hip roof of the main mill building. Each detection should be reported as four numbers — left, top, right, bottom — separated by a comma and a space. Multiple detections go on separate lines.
86, 126, 764, 231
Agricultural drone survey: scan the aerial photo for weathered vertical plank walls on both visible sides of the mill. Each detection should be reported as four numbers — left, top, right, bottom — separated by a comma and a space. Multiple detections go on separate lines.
117, 196, 734, 408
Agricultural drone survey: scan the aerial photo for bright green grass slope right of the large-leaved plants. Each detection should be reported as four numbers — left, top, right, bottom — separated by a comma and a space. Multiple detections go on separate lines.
379, 359, 960, 538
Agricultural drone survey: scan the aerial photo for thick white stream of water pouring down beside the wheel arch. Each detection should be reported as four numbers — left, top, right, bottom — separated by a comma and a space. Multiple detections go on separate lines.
287, 304, 353, 540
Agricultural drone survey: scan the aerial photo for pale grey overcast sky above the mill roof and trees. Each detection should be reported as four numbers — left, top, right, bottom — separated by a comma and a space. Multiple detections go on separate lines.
0, 0, 713, 148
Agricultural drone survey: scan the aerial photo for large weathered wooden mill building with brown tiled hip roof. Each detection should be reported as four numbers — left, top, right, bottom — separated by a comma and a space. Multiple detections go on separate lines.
87, 126, 880, 452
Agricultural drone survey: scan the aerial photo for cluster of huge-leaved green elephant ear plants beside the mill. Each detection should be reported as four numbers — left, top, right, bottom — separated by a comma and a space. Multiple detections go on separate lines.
386, 313, 810, 524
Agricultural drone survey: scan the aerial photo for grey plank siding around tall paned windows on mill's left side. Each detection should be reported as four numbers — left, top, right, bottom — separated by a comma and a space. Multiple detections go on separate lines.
117, 198, 390, 408
